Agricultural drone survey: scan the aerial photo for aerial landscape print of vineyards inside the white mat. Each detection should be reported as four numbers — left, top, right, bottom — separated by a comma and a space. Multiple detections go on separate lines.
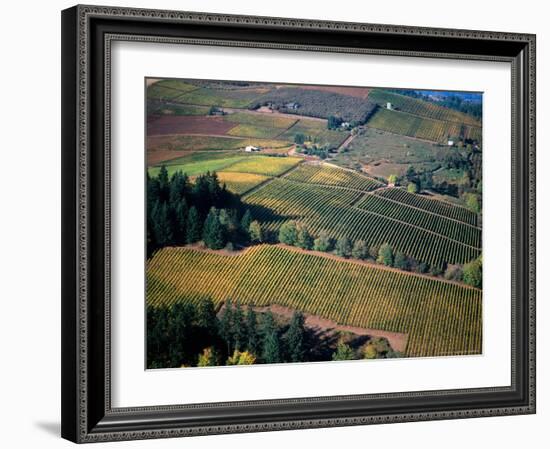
146, 77, 483, 369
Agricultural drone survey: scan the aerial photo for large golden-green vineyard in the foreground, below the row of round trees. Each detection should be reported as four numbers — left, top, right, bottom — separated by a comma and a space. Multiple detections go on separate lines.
147, 245, 482, 357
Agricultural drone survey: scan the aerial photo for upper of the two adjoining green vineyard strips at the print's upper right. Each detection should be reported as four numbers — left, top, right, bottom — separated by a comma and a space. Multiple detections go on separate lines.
368, 89, 481, 126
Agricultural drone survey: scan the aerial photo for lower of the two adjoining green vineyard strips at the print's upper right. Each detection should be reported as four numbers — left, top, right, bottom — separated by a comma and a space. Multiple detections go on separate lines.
367, 108, 481, 143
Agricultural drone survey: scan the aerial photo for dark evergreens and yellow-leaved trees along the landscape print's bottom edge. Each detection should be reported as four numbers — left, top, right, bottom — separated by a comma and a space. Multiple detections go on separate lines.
147, 298, 402, 368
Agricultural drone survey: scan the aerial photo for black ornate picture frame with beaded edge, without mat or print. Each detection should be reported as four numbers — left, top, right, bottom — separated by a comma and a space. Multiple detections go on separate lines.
62, 5, 535, 443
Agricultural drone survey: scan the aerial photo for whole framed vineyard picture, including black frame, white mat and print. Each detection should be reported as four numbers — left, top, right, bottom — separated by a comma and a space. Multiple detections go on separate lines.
62, 6, 535, 442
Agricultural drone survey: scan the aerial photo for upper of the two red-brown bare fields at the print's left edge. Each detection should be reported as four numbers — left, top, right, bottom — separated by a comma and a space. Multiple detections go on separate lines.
147, 115, 236, 136
